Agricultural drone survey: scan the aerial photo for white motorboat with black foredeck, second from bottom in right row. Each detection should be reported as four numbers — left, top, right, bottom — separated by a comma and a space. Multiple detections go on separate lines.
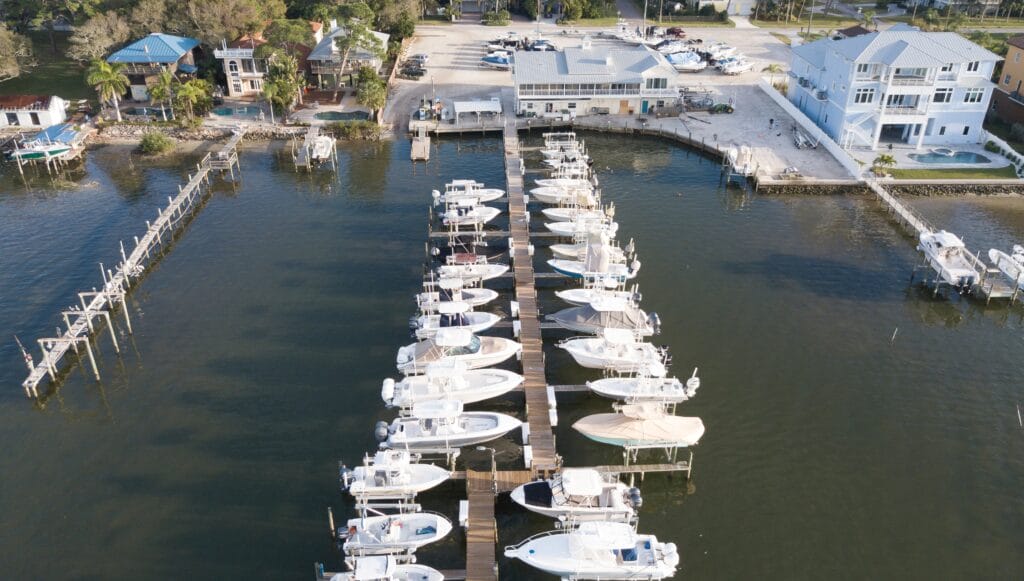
512, 468, 643, 523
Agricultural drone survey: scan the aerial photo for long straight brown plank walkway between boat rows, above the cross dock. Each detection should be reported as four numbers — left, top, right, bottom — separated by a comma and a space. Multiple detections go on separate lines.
504, 118, 559, 472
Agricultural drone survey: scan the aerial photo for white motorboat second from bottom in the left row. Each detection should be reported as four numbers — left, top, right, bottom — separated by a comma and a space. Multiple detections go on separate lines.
342, 512, 452, 555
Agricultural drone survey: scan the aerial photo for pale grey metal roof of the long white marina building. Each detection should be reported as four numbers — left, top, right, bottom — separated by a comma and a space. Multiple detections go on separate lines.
513, 46, 676, 84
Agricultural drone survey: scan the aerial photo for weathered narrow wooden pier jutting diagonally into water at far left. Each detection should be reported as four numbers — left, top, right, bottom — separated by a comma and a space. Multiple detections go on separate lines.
22, 131, 243, 398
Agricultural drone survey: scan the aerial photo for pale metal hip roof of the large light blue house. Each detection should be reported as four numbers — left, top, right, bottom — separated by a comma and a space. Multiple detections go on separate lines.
793, 26, 1002, 69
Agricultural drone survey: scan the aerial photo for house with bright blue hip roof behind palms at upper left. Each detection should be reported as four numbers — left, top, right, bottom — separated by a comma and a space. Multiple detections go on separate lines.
106, 33, 199, 100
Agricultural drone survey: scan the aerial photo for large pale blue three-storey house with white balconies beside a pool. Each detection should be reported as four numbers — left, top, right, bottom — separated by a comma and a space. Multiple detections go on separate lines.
786, 26, 1001, 149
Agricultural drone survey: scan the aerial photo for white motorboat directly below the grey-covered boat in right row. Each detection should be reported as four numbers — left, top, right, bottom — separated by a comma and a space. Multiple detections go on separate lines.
558, 329, 665, 373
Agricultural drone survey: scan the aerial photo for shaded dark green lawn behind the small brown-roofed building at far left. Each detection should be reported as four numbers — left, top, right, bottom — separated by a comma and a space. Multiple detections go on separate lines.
0, 32, 96, 100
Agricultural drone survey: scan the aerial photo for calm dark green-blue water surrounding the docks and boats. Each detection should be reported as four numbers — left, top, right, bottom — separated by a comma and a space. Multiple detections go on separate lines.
0, 135, 1024, 579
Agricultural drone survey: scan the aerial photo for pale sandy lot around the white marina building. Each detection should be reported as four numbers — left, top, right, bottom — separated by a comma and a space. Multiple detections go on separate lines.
385, 24, 850, 178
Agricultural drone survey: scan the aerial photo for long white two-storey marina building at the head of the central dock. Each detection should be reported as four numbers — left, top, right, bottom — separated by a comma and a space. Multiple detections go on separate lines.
512, 42, 680, 117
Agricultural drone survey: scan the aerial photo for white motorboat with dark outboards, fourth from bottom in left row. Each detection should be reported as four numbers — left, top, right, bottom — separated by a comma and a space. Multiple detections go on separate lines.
374, 400, 522, 451
